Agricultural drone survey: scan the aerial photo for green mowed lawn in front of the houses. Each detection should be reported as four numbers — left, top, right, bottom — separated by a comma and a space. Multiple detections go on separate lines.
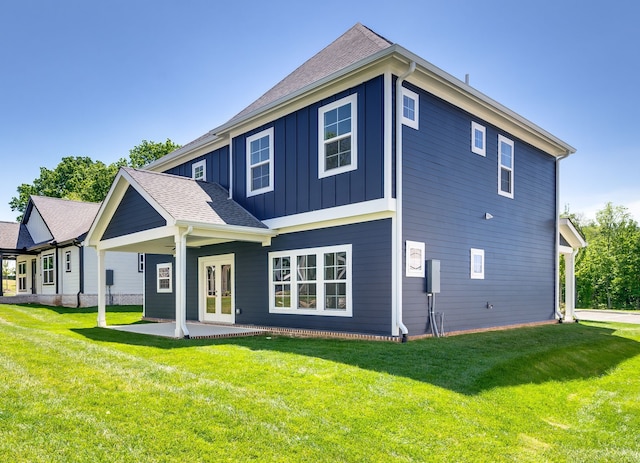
0, 305, 640, 462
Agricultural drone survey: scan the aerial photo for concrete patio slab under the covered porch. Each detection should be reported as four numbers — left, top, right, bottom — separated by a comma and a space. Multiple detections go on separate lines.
107, 322, 265, 339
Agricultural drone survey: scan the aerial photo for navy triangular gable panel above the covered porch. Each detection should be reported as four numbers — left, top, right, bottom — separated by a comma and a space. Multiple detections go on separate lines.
101, 186, 167, 240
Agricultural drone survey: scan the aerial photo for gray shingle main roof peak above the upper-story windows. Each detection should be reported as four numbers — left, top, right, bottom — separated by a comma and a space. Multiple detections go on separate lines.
231, 23, 393, 120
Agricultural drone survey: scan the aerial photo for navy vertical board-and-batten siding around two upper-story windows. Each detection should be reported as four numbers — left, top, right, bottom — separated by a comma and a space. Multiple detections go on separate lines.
233, 77, 384, 220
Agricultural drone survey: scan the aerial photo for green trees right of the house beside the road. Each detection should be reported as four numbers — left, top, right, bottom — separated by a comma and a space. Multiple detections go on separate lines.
564, 203, 640, 309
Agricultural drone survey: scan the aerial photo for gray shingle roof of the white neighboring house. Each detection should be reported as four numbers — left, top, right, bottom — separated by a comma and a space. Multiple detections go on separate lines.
28, 195, 100, 243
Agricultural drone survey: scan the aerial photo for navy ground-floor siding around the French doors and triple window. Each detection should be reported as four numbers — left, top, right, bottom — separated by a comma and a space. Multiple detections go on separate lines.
146, 220, 391, 335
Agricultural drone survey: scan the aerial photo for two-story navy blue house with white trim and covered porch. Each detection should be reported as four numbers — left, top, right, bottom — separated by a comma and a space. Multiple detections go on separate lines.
87, 24, 575, 337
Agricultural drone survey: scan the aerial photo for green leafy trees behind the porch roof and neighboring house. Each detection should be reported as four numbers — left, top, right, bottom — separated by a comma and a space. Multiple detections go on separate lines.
9, 138, 180, 220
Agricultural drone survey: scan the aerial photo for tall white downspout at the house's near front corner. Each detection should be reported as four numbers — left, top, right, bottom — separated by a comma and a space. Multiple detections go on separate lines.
395, 61, 419, 342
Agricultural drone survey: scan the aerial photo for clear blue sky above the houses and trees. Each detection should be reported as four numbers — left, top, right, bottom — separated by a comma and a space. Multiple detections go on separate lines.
0, 0, 640, 225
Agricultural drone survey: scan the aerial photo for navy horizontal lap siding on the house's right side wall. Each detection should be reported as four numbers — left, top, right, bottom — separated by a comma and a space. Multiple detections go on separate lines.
402, 83, 556, 334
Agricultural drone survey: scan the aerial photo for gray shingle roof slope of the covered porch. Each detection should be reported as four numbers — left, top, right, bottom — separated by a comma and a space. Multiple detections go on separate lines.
122, 167, 268, 229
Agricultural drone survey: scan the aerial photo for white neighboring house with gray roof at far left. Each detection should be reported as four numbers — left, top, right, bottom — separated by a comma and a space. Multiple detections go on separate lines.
0, 196, 144, 307
